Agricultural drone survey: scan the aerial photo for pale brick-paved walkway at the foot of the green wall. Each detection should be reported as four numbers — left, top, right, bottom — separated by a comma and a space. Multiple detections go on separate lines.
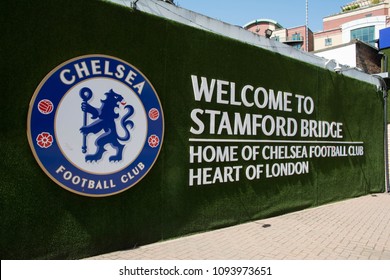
86, 194, 390, 260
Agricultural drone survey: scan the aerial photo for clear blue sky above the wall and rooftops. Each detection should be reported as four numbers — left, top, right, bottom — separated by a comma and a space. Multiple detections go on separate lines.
176, 0, 353, 32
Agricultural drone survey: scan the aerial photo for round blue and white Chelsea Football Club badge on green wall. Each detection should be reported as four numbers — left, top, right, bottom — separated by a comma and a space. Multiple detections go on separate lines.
27, 55, 164, 197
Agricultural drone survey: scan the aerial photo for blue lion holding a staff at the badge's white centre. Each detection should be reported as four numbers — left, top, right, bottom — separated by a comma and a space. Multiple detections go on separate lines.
80, 88, 134, 162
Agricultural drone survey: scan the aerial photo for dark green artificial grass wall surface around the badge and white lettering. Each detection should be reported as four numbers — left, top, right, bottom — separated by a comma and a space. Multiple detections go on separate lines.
0, 0, 384, 259
